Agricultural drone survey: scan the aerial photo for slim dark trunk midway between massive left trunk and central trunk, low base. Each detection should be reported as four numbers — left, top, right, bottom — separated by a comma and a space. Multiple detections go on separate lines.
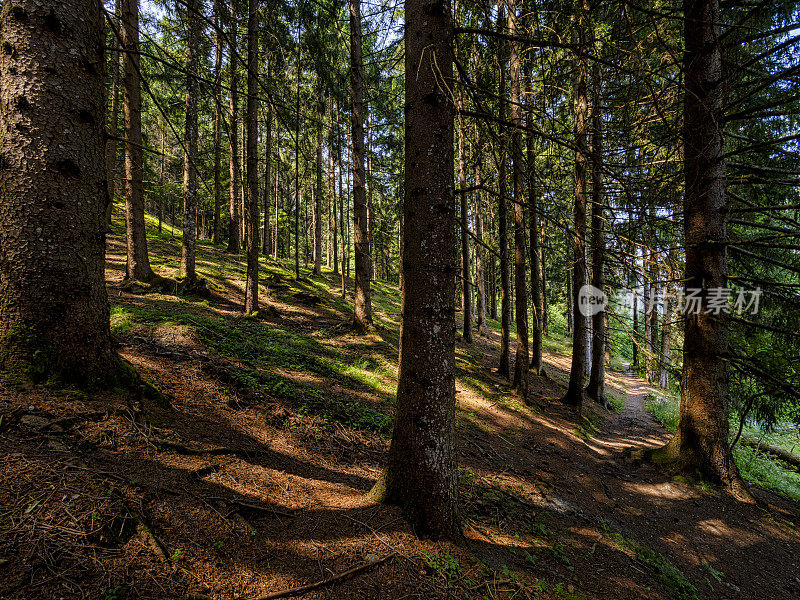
244, 0, 259, 315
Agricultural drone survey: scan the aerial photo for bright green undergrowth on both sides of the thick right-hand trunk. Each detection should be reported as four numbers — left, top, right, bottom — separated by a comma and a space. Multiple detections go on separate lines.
645, 393, 800, 501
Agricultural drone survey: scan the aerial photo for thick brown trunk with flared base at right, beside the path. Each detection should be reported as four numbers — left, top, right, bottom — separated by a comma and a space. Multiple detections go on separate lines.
652, 0, 751, 500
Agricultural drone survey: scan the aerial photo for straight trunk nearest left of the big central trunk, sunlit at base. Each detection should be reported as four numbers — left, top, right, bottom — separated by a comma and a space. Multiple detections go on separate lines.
350, 0, 372, 330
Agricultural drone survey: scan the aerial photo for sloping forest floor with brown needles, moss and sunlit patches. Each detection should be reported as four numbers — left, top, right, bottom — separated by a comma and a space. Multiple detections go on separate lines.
0, 207, 800, 600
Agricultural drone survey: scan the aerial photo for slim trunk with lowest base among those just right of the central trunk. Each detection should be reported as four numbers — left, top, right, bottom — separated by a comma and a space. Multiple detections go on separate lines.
507, 0, 530, 400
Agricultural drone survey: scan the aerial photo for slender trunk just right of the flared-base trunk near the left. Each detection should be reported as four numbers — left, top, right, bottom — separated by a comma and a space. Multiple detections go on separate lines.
181, 0, 202, 286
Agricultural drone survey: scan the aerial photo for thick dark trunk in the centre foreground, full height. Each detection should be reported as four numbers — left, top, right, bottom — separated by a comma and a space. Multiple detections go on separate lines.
372, 0, 461, 539
